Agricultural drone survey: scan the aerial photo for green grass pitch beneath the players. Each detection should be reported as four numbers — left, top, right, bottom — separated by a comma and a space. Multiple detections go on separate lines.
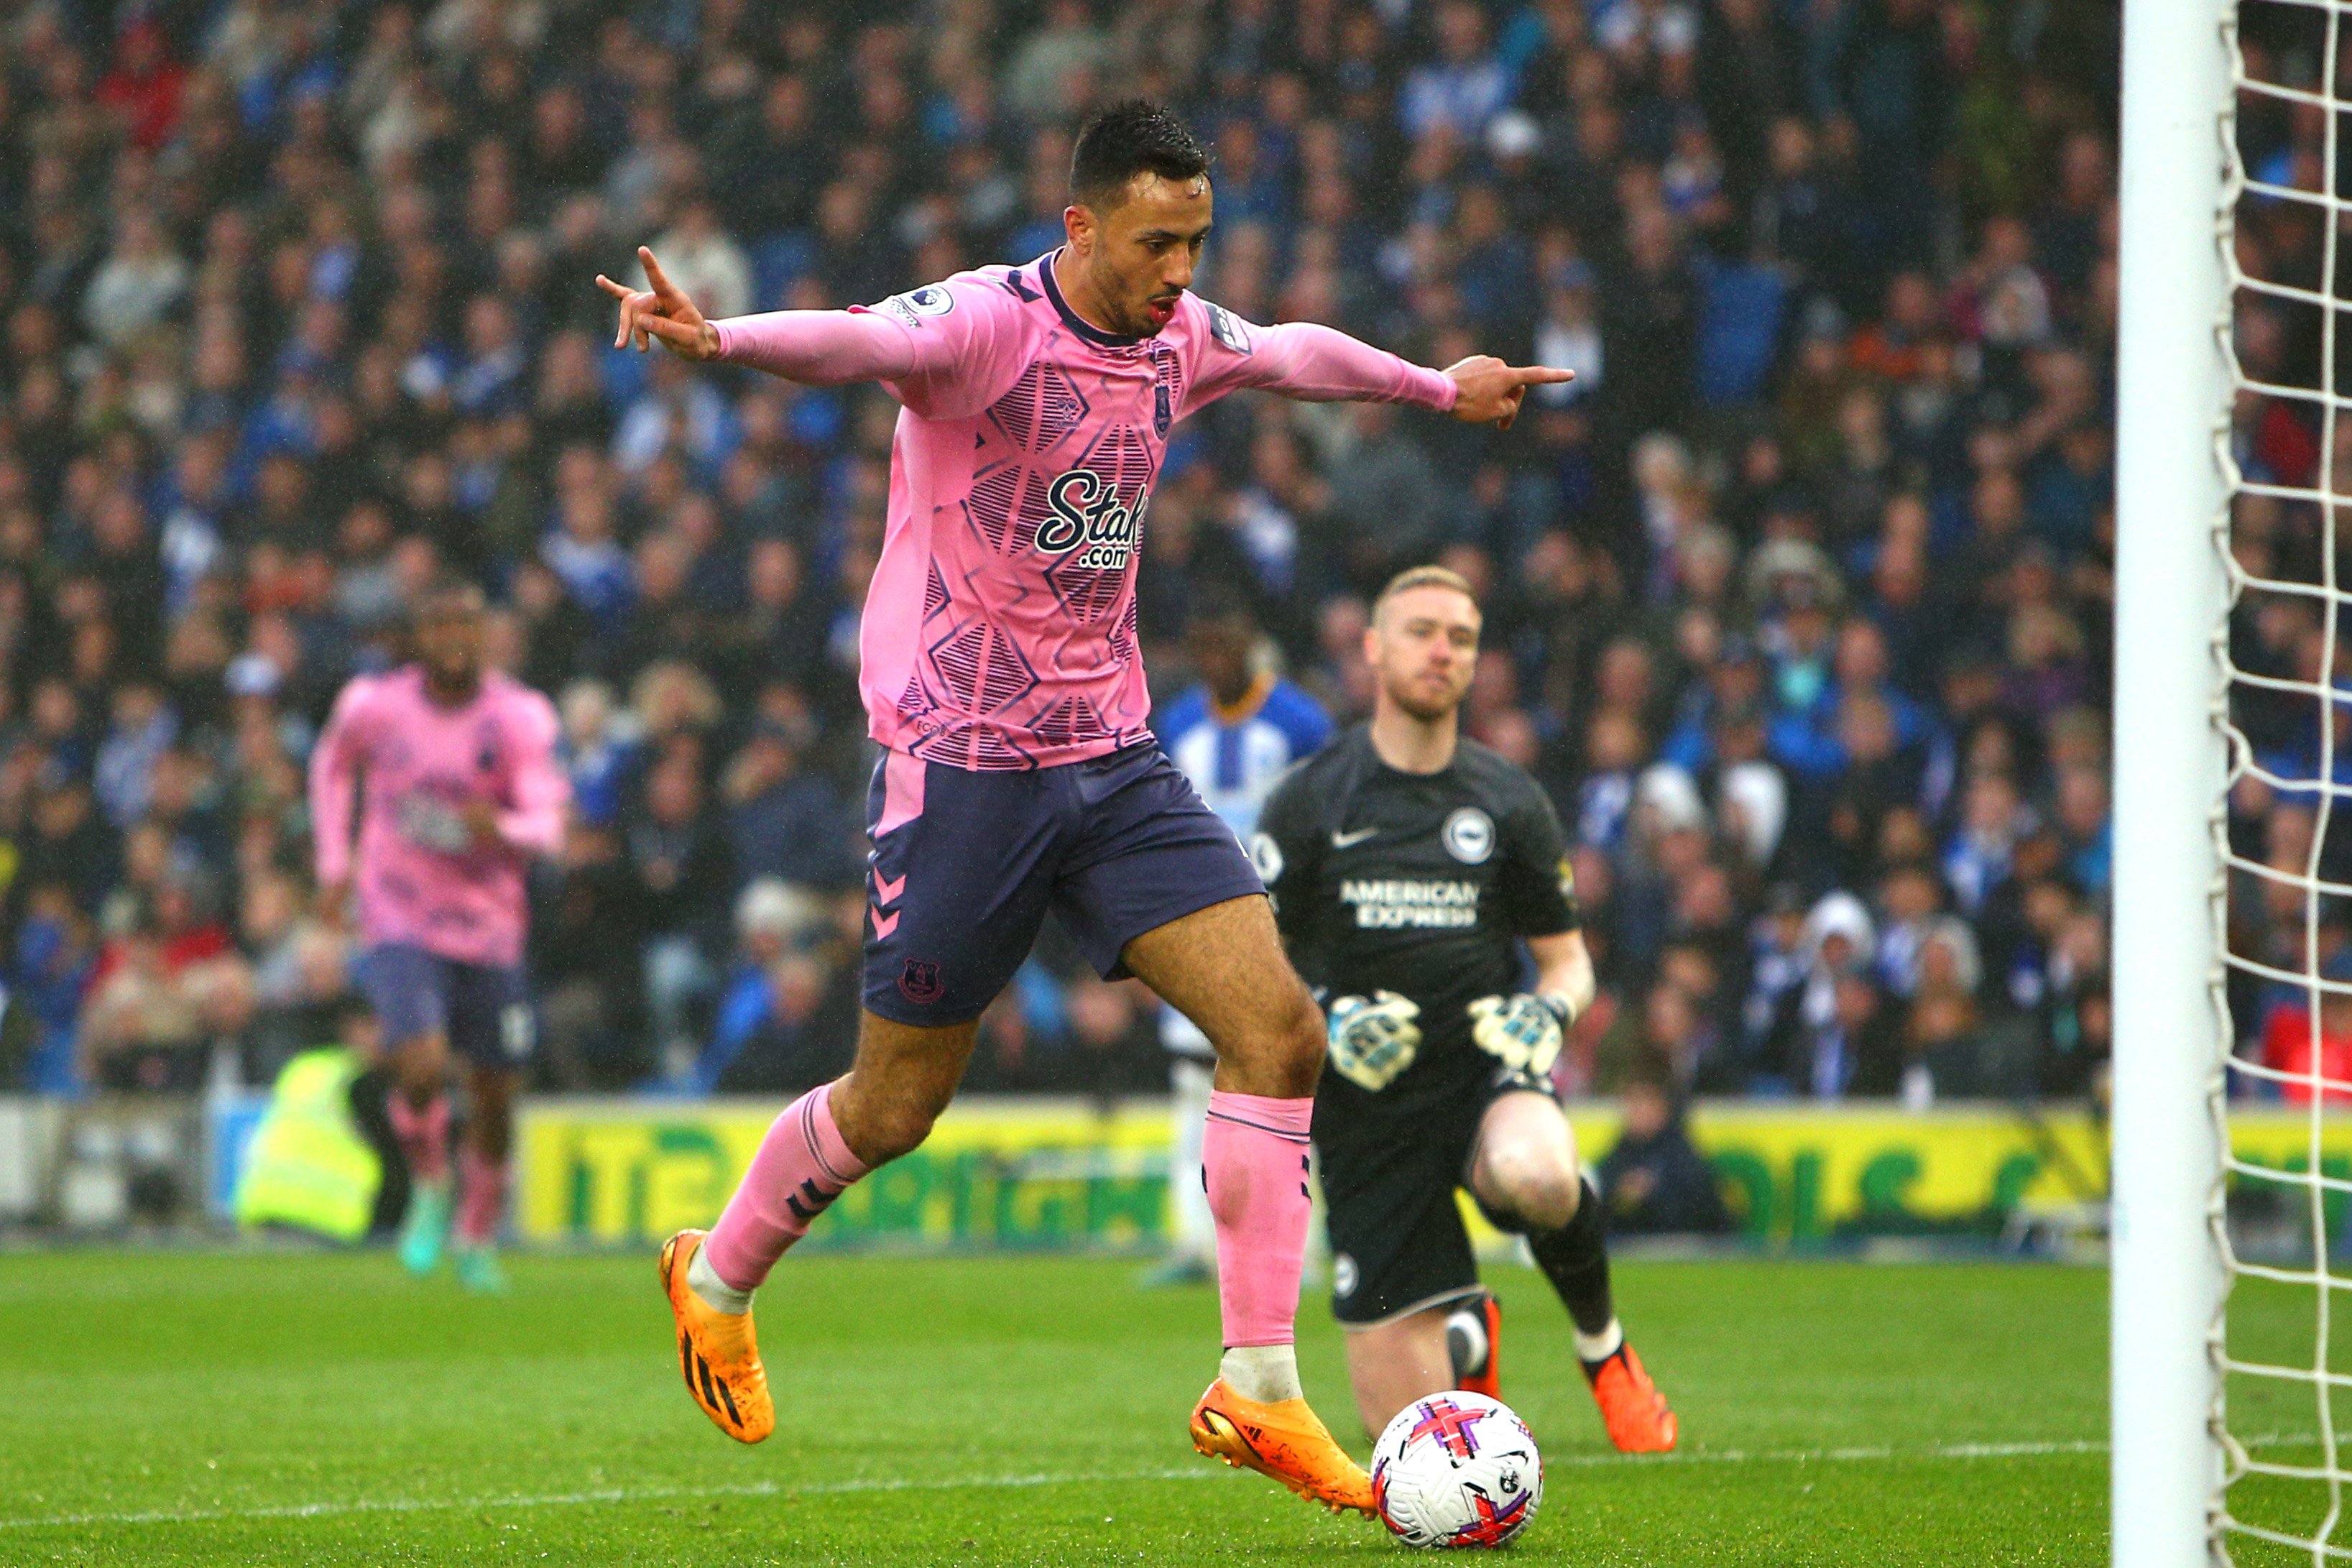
0, 1253, 2126, 1568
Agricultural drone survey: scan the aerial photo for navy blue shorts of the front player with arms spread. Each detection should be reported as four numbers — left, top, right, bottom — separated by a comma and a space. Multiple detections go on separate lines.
865, 743, 1265, 1028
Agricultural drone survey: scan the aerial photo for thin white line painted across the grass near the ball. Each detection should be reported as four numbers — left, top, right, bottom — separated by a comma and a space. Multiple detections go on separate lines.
0, 1439, 2144, 1531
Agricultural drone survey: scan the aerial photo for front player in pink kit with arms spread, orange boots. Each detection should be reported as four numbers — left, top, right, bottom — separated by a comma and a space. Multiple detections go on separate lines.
597, 103, 1569, 1511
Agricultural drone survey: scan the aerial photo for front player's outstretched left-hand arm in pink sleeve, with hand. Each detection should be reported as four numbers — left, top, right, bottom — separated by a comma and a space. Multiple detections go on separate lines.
595, 244, 931, 386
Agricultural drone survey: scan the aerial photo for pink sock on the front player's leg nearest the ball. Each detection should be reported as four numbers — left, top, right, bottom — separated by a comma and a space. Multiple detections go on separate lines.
1199, 1089, 1315, 1350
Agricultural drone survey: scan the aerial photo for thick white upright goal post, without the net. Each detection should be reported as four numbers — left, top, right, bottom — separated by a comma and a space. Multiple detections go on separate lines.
2110, 0, 2234, 1568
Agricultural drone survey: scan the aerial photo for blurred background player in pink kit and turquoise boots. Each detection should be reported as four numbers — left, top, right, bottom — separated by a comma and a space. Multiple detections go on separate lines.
310, 586, 571, 1291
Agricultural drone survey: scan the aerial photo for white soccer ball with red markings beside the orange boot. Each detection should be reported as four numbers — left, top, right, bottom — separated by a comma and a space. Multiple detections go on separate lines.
1371, 1389, 1543, 1547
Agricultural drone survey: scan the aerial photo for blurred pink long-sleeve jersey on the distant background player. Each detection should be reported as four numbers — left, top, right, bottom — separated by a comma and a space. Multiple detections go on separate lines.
310, 665, 571, 969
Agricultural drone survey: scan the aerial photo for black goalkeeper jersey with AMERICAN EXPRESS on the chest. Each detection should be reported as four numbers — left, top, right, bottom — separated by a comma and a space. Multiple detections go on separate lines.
1251, 724, 1576, 1110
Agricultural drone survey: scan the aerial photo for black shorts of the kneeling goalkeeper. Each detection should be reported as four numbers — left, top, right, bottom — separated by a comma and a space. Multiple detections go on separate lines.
1315, 1072, 1550, 1328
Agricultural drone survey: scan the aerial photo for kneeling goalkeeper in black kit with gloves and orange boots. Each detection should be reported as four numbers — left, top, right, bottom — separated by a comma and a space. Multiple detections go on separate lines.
1251, 566, 1674, 1453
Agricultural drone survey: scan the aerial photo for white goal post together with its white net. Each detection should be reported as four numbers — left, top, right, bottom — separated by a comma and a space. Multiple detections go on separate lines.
2110, 0, 2352, 1542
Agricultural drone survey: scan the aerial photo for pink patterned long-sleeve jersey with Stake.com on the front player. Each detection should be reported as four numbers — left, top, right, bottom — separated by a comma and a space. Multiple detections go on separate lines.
717, 252, 1456, 769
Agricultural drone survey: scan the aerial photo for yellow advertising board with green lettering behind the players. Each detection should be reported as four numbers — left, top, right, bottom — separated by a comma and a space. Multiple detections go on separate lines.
517, 1100, 2352, 1248
